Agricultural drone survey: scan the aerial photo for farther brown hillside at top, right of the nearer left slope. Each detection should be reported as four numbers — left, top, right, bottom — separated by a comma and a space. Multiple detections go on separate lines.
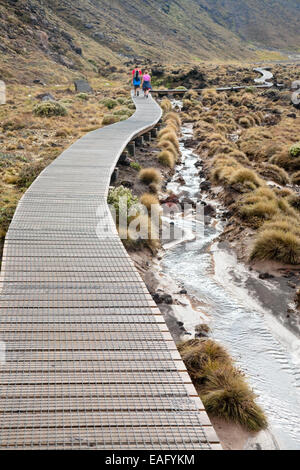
47, 0, 300, 62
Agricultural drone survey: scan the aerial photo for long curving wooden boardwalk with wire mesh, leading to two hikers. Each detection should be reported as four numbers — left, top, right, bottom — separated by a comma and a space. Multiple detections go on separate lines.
0, 93, 221, 450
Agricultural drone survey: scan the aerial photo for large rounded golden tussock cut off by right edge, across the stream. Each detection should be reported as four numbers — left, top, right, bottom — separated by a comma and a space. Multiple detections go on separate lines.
250, 229, 300, 264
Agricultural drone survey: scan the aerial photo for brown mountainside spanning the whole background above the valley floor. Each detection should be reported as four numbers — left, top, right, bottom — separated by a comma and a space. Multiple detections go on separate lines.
0, 0, 300, 83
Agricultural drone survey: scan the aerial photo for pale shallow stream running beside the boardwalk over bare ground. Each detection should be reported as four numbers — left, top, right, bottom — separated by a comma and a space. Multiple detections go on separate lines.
162, 123, 300, 449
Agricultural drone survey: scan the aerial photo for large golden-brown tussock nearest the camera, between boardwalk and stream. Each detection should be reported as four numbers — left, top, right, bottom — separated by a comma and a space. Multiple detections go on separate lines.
178, 339, 267, 431
